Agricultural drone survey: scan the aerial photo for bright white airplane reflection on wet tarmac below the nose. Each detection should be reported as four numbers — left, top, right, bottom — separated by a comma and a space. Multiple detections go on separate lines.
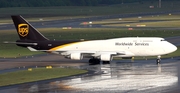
65, 63, 178, 93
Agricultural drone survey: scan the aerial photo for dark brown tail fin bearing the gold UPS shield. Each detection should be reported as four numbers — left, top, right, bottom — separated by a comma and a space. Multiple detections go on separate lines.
11, 15, 48, 41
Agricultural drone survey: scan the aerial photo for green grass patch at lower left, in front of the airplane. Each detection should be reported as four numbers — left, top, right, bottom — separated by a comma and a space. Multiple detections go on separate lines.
0, 68, 87, 86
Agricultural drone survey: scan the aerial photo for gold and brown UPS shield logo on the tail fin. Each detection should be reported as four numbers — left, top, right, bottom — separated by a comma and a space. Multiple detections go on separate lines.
18, 24, 29, 37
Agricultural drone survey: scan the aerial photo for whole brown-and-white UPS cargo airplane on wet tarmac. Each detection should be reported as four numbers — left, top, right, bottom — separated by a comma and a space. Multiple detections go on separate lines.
11, 15, 177, 63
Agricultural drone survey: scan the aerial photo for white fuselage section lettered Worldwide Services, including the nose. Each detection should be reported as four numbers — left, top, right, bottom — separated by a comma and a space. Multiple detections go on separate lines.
56, 37, 177, 57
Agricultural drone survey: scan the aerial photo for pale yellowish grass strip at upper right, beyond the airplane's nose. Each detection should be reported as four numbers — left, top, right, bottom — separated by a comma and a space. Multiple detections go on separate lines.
85, 14, 180, 28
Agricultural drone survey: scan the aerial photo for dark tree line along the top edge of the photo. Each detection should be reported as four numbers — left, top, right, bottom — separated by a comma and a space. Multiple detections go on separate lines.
0, 0, 179, 8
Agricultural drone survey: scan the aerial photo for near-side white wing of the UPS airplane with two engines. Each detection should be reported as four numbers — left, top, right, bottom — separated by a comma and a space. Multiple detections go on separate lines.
27, 47, 128, 61
